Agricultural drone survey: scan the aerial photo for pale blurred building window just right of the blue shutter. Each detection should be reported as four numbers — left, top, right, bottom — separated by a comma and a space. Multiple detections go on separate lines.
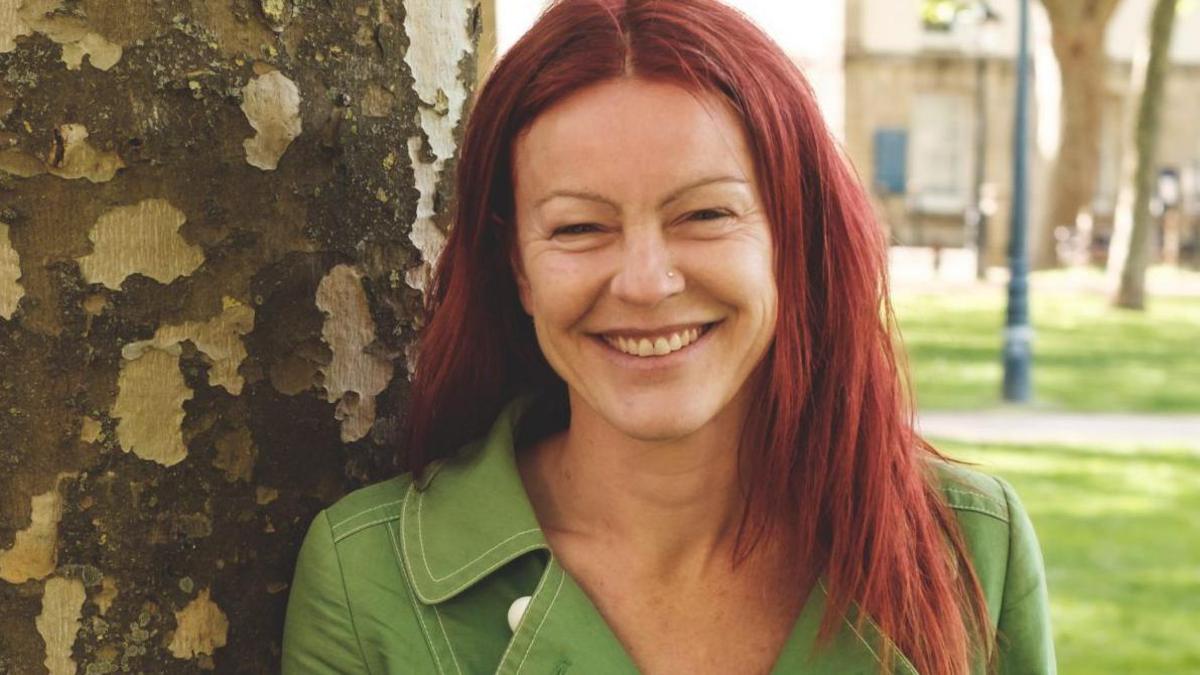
908, 92, 973, 214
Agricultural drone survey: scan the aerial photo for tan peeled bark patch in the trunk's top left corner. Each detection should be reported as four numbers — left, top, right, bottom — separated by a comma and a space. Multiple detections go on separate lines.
10, 0, 121, 71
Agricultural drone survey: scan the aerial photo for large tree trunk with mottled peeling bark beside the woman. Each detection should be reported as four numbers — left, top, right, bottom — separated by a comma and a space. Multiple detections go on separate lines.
0, 0, 479, 674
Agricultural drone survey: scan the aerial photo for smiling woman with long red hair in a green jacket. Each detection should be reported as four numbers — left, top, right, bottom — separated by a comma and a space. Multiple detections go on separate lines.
283, 0, 1054, 675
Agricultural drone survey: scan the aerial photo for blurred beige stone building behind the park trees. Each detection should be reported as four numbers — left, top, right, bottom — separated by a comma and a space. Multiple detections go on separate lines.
844, 0, 1200, 270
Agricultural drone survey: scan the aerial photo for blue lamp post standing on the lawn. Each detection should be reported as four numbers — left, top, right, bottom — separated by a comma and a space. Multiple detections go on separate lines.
1004, 0, 1033, 402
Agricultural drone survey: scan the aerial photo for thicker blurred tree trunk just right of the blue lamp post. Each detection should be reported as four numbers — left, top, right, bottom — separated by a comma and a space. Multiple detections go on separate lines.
1033, 0, 1118, 269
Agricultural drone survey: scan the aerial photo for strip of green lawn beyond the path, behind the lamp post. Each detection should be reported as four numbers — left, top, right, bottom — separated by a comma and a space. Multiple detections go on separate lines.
893, 287, 1200, 413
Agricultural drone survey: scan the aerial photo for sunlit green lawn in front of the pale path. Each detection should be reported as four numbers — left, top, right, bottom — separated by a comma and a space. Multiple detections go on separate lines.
935, 441, 1200, 675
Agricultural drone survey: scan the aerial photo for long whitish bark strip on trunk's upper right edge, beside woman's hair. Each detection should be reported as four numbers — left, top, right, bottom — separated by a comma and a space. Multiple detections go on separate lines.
404, 0, 474, 293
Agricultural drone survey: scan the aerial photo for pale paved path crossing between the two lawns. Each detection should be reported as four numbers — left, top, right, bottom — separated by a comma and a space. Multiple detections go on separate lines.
918, 408, 1200, 450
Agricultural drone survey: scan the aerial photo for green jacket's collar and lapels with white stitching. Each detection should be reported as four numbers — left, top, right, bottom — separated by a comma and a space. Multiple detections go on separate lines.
400, 394, 916, 675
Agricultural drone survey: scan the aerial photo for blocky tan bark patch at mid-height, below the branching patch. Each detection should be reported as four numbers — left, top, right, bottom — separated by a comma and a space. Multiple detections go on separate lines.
113, 346, 192, 466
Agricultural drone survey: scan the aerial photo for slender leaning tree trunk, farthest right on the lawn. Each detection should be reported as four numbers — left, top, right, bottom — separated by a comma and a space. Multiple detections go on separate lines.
1109, 0, 1178, 310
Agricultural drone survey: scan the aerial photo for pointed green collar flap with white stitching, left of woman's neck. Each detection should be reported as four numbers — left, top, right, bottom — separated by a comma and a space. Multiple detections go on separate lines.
400, 394, 548, 604
